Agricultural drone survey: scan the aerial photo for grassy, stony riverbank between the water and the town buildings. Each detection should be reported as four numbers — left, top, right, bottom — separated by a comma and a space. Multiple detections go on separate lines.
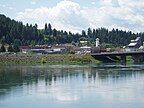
0, 54, 99, 64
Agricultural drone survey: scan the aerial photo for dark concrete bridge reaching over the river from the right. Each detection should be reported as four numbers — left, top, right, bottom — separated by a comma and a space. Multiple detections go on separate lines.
91, 51, 144, 63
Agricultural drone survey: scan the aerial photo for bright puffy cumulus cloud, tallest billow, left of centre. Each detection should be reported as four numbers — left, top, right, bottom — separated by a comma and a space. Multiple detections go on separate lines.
16, 1, 88, 32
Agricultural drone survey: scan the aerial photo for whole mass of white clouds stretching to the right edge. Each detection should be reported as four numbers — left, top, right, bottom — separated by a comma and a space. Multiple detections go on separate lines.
16, 0, 144, 32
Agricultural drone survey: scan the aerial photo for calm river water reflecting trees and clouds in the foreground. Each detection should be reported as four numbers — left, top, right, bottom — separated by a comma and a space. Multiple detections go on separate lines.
0, 64, 144, 108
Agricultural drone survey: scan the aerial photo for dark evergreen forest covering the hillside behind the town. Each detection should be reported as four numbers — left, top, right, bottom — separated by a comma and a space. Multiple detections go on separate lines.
0, 14, 144, 46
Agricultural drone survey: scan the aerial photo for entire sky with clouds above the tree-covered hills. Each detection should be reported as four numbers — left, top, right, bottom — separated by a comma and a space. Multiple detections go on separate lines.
0, 0, 144, 33
